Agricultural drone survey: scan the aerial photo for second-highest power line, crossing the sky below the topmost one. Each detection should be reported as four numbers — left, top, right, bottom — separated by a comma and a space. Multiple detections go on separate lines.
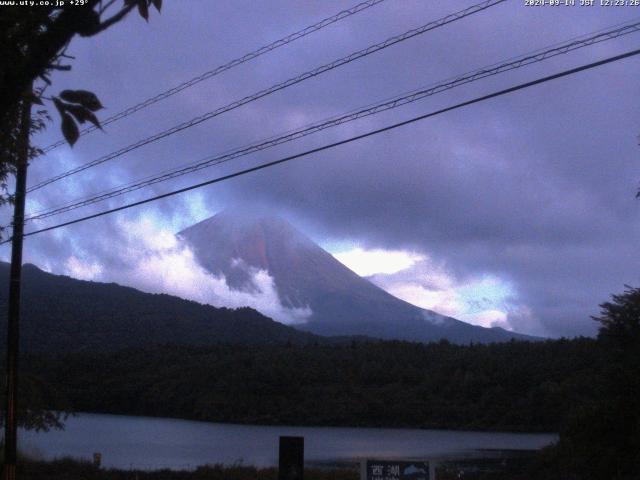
27, 0, 506, 192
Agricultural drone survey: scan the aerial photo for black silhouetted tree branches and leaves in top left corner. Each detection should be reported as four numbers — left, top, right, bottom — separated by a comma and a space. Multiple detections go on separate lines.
0, 0, 162, 202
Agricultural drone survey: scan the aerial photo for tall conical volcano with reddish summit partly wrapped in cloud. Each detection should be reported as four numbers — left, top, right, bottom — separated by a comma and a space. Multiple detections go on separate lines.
178, 211, 533, 343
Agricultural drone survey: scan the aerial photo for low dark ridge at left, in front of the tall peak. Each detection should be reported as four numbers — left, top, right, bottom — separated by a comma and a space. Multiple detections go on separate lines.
0, 262, 322, 353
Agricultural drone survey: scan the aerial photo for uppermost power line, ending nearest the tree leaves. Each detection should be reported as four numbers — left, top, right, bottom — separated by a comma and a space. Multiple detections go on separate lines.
42, 0, 385, 153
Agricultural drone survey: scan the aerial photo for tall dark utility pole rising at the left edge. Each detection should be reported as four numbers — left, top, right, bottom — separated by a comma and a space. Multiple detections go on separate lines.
4, 89, 31, 480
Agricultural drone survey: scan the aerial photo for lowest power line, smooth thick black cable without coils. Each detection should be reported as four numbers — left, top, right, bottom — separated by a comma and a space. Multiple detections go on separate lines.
6, 49, 640, 245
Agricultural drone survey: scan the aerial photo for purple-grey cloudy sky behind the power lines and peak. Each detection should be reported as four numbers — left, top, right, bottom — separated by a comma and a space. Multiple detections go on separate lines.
0, 0, 640, 337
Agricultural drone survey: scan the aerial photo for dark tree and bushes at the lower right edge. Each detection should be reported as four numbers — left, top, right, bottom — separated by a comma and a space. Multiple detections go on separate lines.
536, 288, 640, 480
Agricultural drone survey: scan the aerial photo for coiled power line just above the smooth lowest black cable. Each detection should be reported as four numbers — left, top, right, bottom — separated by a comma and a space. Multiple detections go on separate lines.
26, 21, 640, 220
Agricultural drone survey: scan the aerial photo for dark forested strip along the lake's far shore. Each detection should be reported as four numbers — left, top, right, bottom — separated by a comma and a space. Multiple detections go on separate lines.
24, 339, 600, 431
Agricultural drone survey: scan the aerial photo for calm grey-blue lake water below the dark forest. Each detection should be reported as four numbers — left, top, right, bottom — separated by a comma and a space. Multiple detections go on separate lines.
19, 414, 557, 470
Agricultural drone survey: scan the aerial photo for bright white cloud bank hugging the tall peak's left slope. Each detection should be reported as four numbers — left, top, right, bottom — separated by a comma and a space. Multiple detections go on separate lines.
59, 219, 312, 324
